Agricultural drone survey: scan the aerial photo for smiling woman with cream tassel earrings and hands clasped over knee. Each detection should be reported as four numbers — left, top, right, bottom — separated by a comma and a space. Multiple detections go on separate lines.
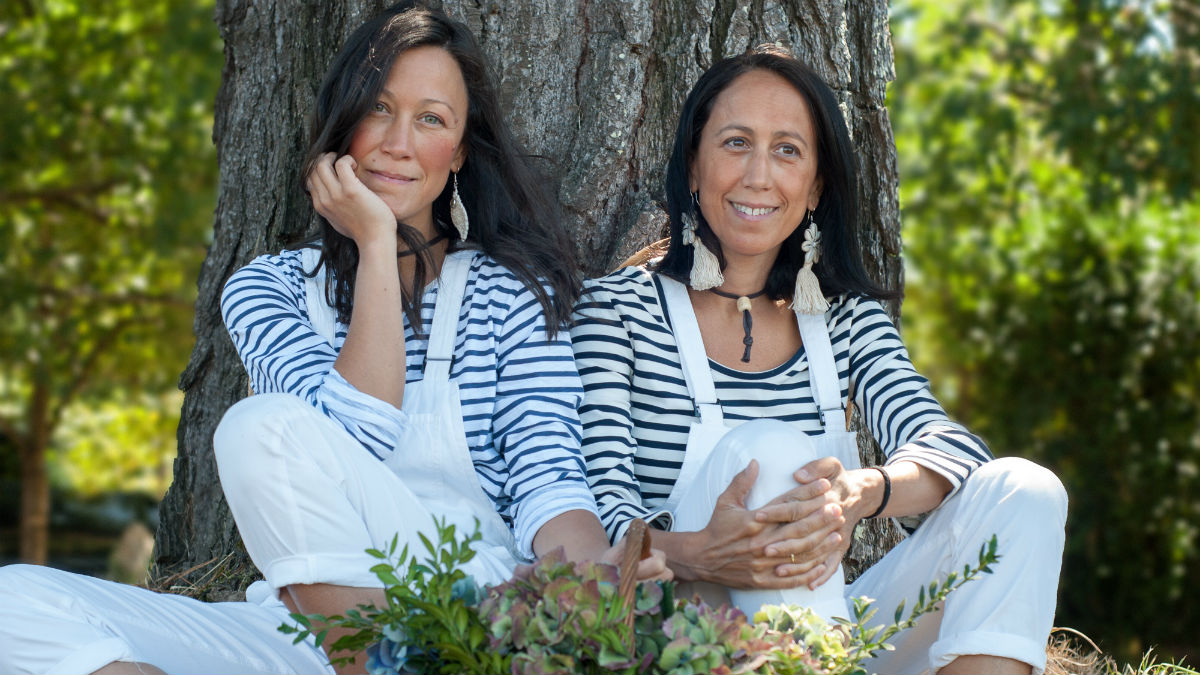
571, 47, 1066, 673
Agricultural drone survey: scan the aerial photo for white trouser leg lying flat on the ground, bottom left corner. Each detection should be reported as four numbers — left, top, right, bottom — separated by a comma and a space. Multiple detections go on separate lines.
0, 565, 334, 675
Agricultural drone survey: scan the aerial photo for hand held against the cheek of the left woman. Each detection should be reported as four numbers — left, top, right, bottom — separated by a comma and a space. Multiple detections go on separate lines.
305, 153, 396, 251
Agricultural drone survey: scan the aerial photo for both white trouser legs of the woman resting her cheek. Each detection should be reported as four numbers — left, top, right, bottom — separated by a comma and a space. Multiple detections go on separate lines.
0, 394, 508, 674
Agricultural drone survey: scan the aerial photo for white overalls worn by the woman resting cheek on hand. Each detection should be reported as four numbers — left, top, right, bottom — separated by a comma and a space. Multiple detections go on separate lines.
0, 252, 518, 674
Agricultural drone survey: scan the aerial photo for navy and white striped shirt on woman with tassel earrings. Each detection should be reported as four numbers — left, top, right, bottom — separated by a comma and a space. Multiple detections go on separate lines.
571, 268, 991, 537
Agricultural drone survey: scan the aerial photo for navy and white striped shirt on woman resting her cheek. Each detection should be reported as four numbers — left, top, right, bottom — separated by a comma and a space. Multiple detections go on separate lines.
221, 251, 595, 557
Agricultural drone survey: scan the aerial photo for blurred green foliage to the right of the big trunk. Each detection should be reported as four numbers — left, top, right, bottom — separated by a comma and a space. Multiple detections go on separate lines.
888, 0, 1200, 659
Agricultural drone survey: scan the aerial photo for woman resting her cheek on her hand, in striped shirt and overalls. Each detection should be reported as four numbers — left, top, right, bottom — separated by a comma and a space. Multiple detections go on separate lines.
0, 5, 670, 673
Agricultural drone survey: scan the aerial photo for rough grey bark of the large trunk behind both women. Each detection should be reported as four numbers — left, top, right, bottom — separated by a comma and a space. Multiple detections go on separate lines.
156, 0, 902, 586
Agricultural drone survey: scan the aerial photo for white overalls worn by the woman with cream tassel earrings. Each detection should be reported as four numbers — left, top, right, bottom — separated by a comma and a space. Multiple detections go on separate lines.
658, 275, 1067, 675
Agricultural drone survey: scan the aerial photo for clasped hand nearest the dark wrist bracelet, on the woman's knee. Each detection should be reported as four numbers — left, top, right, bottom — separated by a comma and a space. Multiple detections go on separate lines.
755, 456, 878, 589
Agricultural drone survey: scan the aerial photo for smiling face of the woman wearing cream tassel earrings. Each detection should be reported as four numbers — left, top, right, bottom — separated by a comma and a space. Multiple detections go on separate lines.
690, 70, 821, 268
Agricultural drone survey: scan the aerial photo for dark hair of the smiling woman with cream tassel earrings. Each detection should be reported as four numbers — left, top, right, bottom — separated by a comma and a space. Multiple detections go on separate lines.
658, 44, 898, 300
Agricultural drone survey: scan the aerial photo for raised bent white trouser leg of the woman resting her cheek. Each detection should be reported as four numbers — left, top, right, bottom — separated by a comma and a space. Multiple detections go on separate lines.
214, 394, 511, 589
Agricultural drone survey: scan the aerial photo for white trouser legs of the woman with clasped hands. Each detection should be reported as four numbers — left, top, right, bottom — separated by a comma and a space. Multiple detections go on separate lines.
676, 422, 1067, 675
